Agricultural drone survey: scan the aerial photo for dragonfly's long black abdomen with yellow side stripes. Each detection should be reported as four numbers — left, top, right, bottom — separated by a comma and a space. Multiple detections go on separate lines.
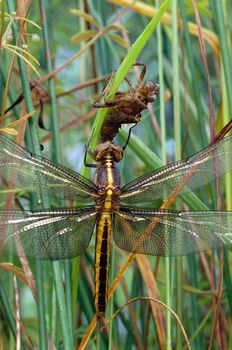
94, 212, 112, 317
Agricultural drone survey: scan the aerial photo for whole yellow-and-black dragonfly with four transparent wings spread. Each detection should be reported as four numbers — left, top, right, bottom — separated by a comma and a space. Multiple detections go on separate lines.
0, 135, 232, 317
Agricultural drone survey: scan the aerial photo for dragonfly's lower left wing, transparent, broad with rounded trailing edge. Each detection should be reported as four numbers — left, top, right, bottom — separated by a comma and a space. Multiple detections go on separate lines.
0, 208, 96, 260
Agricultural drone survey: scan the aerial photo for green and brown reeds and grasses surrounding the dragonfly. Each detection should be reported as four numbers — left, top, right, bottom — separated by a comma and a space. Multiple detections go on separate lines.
0, 0, 232, 350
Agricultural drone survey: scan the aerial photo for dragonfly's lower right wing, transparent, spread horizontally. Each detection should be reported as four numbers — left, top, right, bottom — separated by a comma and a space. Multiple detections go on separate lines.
113, 208, 232, 256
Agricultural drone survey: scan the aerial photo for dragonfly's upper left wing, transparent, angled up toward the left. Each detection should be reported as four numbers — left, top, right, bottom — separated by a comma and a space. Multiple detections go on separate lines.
0, 135, 97, 204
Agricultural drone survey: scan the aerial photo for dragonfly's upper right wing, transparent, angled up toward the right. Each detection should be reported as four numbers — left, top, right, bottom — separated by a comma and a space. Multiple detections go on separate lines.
120, 136, 232, 204
